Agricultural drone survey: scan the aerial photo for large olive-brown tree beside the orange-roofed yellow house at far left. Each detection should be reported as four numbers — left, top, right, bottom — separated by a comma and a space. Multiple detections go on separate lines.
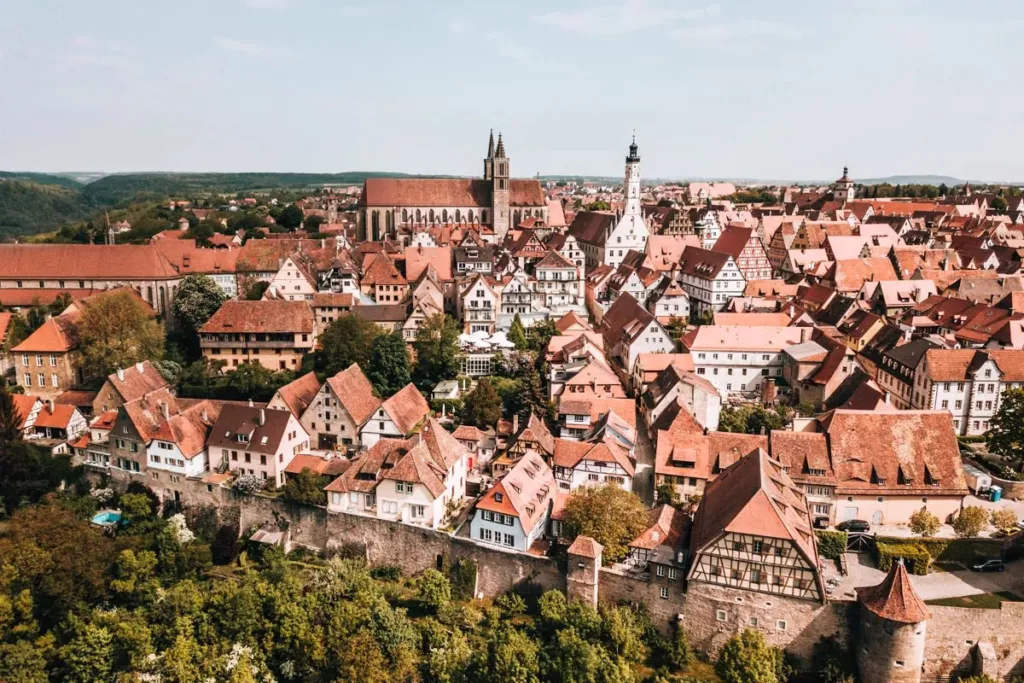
77, 292, 164, 377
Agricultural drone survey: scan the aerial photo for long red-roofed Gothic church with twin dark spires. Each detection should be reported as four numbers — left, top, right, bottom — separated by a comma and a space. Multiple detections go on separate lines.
358, 131, 548, 243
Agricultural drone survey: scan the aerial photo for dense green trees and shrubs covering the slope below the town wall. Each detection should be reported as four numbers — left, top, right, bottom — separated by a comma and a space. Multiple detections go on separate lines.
0, 492, 712, 683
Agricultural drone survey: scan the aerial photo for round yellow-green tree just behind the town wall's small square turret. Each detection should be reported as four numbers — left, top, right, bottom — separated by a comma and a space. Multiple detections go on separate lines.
564, 483, 647, 564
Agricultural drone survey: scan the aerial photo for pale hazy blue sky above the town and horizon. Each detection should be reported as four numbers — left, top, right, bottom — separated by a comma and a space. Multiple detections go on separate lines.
0, 0, 1024, 180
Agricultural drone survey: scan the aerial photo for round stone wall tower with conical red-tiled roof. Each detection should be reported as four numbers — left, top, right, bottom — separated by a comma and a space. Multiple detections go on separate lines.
855, 560, 931, 683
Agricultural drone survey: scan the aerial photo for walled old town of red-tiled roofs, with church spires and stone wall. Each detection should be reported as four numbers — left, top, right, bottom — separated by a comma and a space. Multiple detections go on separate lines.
0, 134, 1024, 683
